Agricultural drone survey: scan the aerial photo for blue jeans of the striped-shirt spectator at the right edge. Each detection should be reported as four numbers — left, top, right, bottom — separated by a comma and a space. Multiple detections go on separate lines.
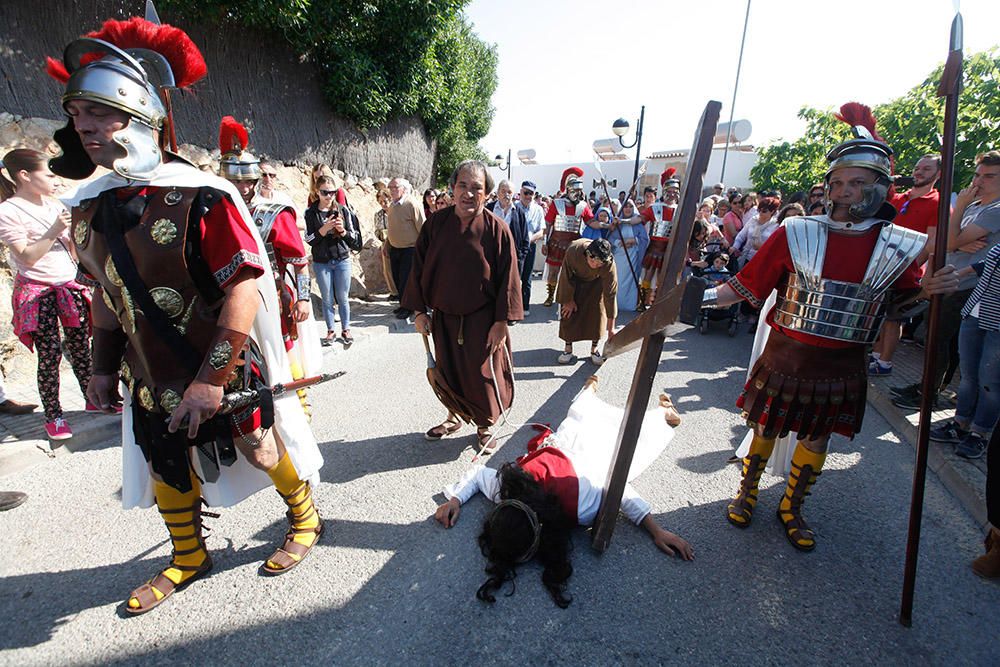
955, 317, 1000, 435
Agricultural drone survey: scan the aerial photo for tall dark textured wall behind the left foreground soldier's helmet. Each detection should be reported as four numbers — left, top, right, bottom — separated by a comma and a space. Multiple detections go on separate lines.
0, 0, 435, 188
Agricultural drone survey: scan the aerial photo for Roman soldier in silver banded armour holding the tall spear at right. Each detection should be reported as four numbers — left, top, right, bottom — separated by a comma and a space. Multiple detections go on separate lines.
703, 103, 958, 551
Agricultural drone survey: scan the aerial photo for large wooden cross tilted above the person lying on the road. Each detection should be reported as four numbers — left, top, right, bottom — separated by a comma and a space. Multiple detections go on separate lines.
591, 100, 722, 551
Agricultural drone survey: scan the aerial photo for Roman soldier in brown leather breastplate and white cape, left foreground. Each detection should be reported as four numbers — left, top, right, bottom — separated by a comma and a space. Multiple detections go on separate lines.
48, 11, 323, 614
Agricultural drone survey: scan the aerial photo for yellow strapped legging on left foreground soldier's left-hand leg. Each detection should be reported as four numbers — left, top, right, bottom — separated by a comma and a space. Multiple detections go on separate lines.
128, 475, 208, 609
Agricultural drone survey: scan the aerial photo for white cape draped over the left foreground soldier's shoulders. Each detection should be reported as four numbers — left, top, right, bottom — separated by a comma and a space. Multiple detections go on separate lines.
61, 161, 323, 509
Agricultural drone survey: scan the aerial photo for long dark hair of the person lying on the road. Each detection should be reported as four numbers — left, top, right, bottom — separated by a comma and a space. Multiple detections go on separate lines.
476, 463, 576, 609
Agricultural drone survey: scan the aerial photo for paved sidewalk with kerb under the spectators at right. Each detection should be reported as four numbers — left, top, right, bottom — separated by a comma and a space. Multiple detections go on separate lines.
868, 343, 987, 530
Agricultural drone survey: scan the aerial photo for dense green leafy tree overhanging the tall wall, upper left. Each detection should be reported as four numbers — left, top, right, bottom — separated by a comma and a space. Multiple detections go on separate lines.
161, 0, 497, 181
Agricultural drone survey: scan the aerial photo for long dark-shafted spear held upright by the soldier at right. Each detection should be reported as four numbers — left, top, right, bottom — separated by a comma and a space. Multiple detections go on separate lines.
899, 6, 963, 627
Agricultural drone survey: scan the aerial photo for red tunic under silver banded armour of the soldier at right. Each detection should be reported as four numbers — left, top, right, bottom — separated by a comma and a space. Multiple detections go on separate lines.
727, 226, 920, 348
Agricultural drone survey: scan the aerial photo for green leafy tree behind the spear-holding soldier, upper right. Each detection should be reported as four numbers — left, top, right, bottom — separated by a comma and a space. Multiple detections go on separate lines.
750, 47, 1000, 192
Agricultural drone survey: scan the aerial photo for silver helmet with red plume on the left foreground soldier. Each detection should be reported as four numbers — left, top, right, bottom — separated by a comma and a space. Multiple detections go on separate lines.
46, 10, 207, 181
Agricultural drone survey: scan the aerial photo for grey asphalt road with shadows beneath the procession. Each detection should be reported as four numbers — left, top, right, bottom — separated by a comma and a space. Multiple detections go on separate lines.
0, 283, 1000, 665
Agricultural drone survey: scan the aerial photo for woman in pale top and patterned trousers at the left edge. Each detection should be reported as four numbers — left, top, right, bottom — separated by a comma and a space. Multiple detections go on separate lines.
0, 148, 94, 440
